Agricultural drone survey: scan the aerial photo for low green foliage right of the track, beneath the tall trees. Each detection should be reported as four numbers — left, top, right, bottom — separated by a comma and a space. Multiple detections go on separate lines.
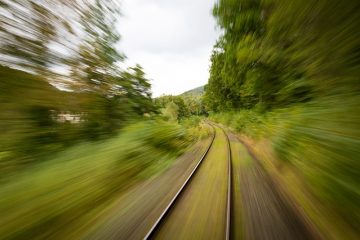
210, 99, 360, 227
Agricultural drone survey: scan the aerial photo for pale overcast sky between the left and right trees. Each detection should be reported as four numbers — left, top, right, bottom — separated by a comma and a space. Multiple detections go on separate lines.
118, 0, 219, 97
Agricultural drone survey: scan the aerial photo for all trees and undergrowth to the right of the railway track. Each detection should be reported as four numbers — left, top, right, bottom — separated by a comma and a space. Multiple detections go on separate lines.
204, 0, 360, 231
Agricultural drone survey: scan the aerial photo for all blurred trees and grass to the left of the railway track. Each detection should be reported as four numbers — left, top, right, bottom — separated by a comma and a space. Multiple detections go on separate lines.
0, 0, 208, 239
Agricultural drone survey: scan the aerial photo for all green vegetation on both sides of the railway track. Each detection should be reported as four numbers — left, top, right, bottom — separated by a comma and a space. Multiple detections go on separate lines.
0, 0, 360, 239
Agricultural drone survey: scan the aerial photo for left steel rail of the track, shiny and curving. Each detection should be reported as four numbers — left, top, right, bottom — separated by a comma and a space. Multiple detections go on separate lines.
143, 124, 216, 240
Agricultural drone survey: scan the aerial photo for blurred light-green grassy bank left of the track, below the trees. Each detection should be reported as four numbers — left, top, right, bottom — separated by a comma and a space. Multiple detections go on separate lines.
0, 121, 194, 239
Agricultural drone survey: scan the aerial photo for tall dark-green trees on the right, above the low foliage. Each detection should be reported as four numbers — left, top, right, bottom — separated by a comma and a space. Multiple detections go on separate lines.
205, 0, 360, 110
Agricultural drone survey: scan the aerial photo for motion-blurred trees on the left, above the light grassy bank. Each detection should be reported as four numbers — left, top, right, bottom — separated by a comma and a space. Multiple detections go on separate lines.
0, 0, 155, 174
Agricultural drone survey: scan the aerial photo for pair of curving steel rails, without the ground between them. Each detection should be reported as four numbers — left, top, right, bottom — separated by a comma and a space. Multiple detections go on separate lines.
144, 124, 232, 240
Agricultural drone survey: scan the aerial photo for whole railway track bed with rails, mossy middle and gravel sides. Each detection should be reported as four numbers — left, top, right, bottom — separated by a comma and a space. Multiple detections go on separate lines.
89, 124, 322, 240
